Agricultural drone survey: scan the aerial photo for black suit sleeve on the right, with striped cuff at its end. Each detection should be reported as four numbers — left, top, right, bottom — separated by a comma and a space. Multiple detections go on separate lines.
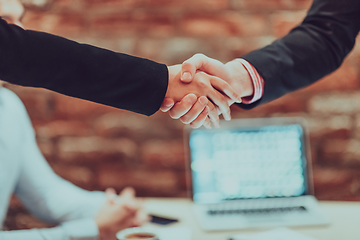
239, 0, 360, 109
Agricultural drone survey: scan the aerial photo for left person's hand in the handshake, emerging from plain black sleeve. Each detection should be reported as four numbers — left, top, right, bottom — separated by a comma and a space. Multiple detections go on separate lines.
166, 65, 240, 127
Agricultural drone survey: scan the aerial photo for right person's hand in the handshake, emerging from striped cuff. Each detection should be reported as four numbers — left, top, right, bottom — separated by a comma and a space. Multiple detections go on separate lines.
161, 54, 254, 127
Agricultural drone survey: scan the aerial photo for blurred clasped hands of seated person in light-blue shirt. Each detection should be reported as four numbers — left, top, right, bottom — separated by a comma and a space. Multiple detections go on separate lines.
95, 188, 149, 240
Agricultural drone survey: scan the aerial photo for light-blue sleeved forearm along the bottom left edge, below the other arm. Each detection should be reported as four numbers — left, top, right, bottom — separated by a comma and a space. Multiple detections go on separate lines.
0, 219, 99, 240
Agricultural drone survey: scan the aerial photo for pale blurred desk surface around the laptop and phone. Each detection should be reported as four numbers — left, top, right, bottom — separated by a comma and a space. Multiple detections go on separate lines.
145, 198, 360, 240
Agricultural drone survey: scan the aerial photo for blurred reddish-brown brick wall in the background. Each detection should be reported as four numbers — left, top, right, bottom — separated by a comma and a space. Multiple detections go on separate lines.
2, 0, 360, 229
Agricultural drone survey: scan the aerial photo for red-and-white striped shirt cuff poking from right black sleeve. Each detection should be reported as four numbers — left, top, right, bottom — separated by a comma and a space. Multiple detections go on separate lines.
236, 58, 265, 104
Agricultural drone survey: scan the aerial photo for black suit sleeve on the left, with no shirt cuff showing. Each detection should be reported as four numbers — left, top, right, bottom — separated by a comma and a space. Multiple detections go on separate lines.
0, 19, 168, 115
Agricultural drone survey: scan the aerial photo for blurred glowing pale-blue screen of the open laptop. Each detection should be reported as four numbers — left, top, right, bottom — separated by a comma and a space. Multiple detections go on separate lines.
189, 121, 307, 203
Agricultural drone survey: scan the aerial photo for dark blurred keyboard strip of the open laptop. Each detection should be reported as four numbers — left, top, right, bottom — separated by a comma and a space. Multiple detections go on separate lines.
207, 206, 307, 215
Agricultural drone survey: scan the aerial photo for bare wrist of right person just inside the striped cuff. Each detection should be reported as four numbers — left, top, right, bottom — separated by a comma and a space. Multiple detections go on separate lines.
225, 60, 254, 97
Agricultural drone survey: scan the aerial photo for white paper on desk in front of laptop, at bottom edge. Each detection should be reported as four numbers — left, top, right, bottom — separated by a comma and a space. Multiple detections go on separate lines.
230, 228, 316, 240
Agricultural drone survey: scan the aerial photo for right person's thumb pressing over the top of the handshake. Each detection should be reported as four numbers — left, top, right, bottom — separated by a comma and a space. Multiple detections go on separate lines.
180, 53, 227, 83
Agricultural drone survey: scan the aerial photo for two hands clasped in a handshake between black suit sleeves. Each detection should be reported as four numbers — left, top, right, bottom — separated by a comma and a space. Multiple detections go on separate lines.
160, 54, 254, 128
